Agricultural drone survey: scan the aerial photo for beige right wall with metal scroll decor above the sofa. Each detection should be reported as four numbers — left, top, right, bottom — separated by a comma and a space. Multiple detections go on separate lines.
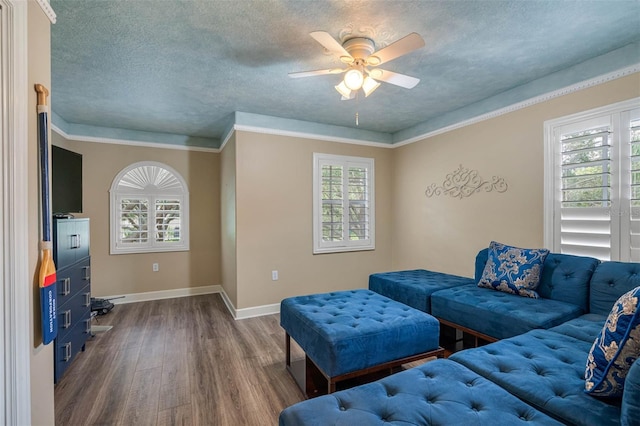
392, 74, 640, 276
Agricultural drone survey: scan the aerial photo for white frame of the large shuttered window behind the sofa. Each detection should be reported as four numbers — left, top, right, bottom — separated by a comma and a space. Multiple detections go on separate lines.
543, 98, 640, 260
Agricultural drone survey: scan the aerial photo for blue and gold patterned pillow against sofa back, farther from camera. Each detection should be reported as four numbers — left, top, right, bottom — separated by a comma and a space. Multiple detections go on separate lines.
478, 241, 549, 299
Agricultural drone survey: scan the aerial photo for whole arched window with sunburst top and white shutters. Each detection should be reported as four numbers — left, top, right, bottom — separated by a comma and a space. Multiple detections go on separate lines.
109, 161, 189, 254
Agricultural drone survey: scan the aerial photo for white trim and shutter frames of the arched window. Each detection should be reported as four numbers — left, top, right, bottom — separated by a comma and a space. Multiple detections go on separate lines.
109, 161, 189, 254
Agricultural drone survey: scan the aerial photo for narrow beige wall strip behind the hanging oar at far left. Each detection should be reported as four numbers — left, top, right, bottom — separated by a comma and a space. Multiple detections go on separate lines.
26, 1, 55, 425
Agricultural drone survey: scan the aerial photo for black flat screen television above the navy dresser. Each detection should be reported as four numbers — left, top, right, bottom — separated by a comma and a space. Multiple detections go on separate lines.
51, 145, 82, 215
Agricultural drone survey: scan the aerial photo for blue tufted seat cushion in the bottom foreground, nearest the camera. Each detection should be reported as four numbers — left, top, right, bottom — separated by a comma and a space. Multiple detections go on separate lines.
279, 360, 560, 426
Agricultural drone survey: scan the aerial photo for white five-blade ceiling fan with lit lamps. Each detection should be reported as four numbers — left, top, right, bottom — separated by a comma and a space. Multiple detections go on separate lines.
289, 31, 424, 100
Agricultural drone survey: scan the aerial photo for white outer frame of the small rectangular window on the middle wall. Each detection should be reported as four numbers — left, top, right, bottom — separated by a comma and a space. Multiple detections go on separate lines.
313, 153, 376, 254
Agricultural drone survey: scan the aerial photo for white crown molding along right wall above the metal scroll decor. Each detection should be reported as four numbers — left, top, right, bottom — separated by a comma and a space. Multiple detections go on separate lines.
393, 63, 640, 148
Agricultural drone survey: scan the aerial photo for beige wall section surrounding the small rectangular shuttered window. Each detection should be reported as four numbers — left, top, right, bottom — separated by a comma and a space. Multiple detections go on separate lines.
236, 131, 392, 309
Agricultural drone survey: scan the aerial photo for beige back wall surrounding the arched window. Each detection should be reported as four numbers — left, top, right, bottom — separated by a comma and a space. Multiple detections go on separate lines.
52, 132, 221, 296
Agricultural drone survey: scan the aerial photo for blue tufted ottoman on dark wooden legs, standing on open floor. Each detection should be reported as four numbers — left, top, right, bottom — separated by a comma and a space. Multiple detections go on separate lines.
280, 290, 444, 397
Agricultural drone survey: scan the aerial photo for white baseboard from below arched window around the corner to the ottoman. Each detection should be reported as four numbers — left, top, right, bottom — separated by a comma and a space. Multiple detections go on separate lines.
100, 285, 280, 320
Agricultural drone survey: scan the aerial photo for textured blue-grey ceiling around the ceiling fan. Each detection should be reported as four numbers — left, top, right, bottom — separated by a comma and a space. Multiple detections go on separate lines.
51, 0, 640, 147
